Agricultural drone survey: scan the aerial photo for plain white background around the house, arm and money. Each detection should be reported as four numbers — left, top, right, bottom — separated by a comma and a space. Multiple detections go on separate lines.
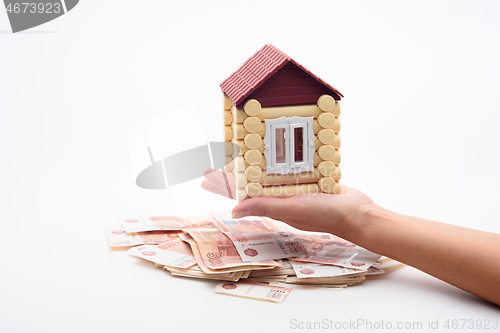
0, 0, 500, 332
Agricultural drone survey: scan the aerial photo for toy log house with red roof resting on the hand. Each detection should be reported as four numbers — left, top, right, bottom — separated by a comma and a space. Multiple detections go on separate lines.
220, 45, 343, 202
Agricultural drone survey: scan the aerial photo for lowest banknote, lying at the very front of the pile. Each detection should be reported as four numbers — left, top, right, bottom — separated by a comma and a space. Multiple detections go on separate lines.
214, 282, 292, 303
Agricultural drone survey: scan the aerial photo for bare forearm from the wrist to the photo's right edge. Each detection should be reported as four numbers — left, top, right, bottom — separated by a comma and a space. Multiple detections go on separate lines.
343, 205, 500, 305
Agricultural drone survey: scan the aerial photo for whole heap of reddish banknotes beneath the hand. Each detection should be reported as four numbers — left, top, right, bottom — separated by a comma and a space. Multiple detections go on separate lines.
105, 214, 400, 303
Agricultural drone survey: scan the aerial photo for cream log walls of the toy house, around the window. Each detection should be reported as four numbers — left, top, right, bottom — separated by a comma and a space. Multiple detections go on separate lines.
223, 95, 341, 202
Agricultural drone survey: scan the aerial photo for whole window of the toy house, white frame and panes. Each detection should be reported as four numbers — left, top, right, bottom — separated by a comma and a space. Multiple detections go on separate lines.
264, 117, 314, 174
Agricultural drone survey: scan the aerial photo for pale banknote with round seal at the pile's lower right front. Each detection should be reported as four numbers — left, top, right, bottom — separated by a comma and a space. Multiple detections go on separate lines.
290, 260, 384, 279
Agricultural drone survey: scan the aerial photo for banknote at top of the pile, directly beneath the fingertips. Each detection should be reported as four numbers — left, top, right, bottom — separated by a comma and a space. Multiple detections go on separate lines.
210, 214, 282, 233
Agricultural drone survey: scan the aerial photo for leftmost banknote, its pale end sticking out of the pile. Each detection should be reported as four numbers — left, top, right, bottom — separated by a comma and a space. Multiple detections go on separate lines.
104, 229, 178, 247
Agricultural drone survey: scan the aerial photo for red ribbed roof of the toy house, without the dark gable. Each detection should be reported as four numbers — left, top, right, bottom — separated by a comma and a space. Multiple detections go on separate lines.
220, 44, 344, 105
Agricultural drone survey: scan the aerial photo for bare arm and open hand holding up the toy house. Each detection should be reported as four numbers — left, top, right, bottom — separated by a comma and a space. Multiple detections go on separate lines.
202, 174, 500, 305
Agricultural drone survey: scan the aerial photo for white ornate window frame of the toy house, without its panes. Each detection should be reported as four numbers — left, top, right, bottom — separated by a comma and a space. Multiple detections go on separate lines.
264, 116, 315, 175
